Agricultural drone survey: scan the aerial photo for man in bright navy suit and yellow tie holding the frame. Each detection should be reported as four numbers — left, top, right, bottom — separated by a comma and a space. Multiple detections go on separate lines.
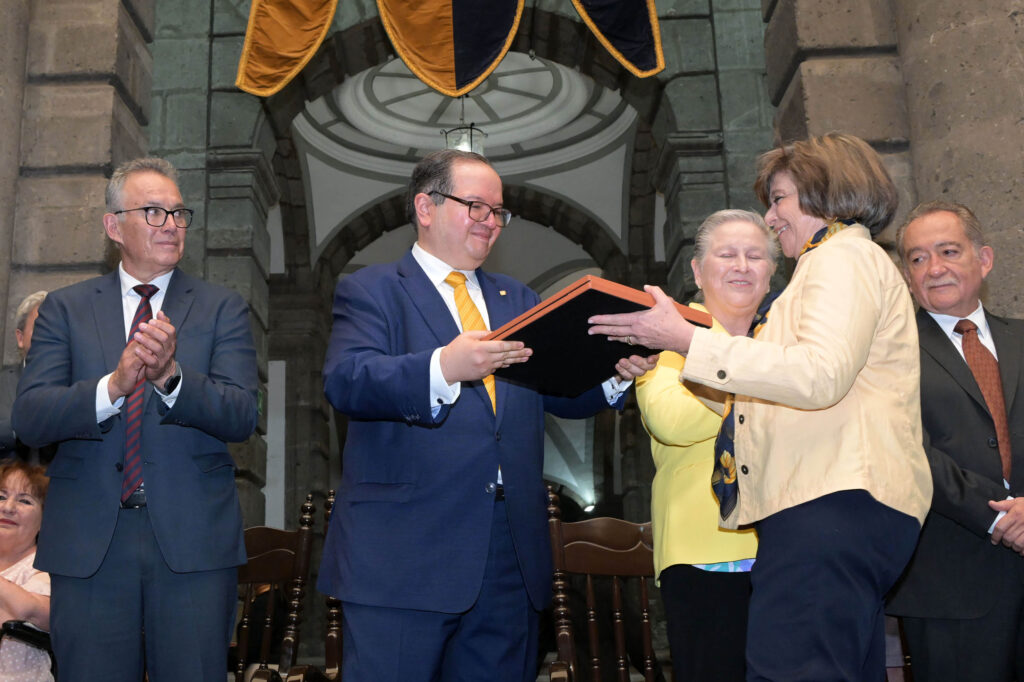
318, 151, 656, 682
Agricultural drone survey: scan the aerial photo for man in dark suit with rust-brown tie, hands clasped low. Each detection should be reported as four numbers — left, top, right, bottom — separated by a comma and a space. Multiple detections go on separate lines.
889, 202, 1024, 682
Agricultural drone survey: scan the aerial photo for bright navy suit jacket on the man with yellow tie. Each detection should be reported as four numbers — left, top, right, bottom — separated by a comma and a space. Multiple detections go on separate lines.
318, 253, 614, 612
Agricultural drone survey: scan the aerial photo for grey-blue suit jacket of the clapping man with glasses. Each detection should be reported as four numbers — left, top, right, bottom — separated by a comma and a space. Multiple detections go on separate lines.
13, 269, 258, 578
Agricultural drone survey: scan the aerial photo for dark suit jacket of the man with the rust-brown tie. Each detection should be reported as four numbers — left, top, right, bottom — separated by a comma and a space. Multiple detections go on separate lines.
889, 309, 1024, 619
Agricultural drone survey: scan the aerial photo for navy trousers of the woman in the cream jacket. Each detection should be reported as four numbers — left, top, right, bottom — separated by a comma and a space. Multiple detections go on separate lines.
746, 491, 921, 682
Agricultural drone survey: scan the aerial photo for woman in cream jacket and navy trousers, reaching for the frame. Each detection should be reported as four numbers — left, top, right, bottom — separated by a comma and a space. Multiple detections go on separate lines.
591, 134, 932, 682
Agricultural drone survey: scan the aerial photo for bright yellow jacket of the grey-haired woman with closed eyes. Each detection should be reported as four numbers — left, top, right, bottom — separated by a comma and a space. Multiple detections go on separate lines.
636, 303, 758, 576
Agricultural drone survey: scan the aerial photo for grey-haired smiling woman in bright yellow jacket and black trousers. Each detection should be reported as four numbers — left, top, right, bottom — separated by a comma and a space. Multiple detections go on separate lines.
637, 210, 778, 682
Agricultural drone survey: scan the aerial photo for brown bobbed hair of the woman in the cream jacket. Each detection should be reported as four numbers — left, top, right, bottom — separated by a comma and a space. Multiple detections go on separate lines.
754, 133, 899, 236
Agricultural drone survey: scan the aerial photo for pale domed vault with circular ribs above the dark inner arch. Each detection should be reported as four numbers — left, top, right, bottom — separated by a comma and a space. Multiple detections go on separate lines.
291, 48, 637, 273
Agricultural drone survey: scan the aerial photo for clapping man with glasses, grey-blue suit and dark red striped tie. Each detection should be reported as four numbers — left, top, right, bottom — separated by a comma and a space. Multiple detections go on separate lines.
13, 159, 257, 682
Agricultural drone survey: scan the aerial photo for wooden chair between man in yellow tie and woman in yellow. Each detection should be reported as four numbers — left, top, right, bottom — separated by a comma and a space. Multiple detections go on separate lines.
548, 487, 655, 682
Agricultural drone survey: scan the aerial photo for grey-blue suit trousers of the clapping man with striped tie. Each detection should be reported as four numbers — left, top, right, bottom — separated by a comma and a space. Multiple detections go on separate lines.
50, 508, 239, 682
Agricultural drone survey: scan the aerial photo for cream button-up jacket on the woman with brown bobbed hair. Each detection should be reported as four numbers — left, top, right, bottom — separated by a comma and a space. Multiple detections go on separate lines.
682, 225, 932, 527
